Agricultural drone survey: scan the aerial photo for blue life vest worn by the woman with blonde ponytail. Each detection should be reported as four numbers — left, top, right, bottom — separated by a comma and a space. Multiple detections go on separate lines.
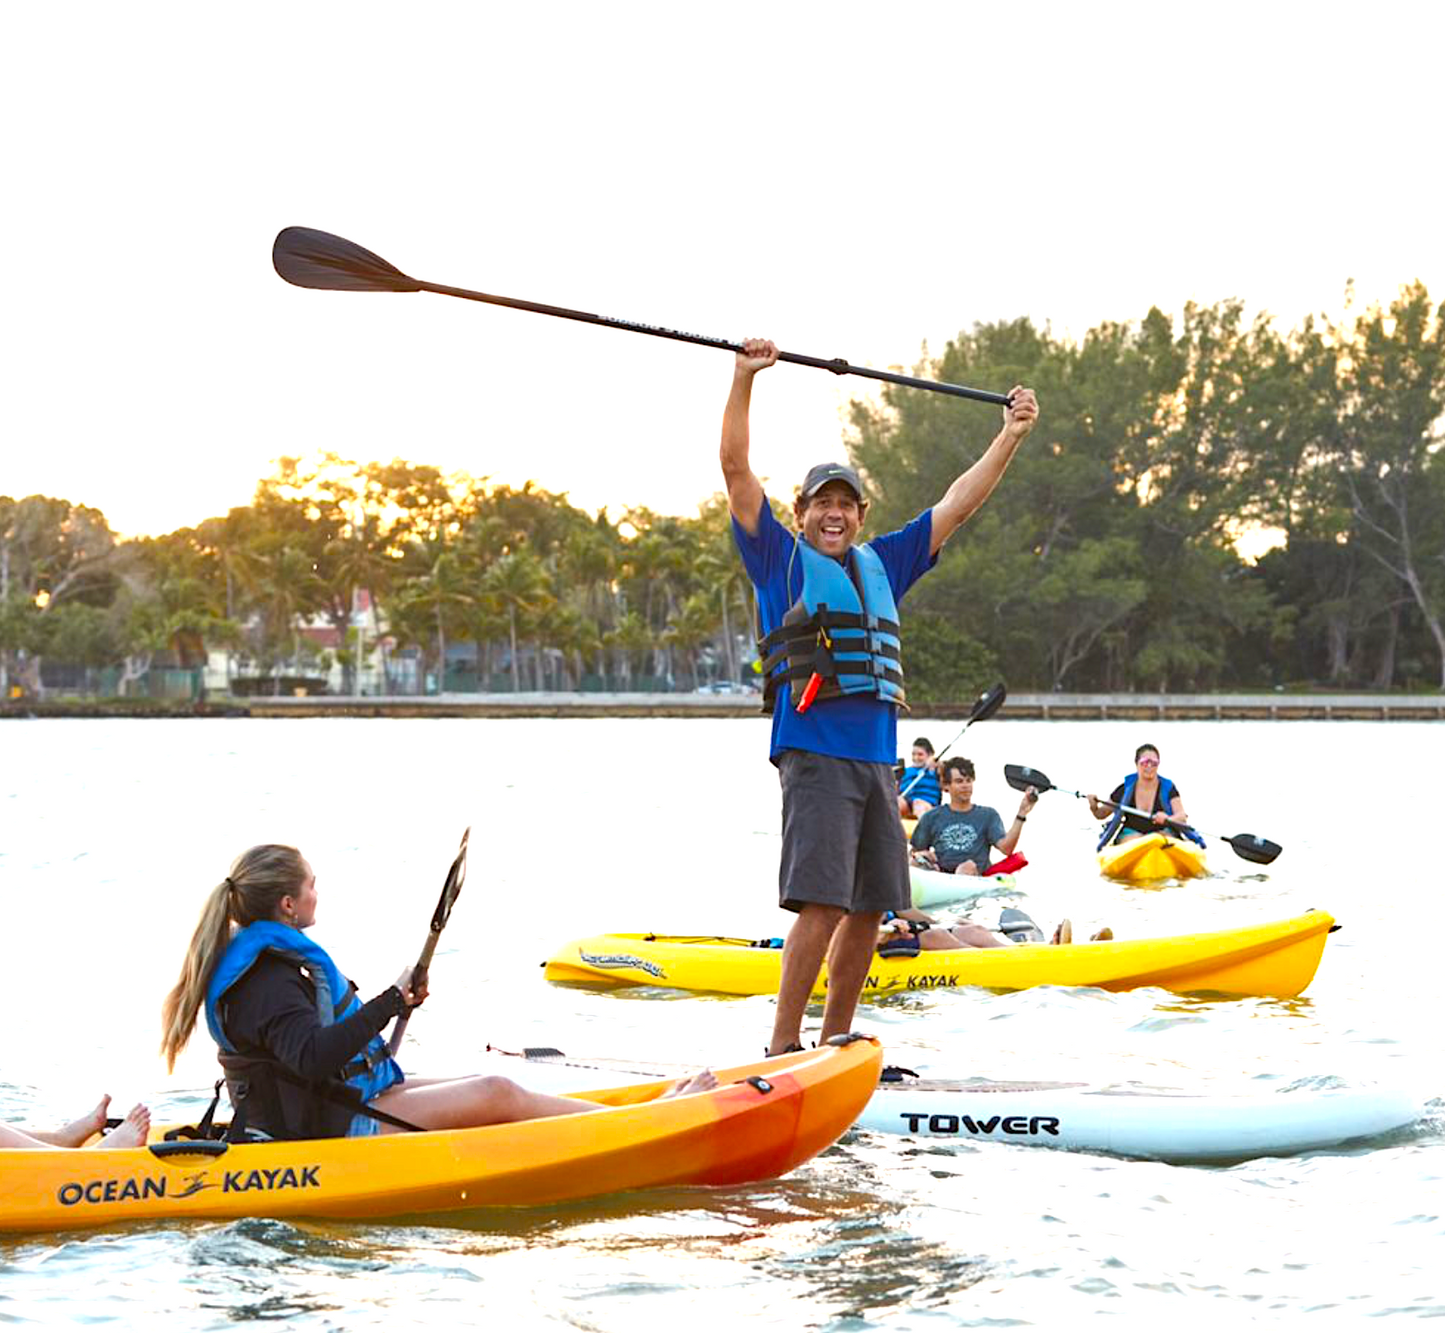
205, 921, 405, 1102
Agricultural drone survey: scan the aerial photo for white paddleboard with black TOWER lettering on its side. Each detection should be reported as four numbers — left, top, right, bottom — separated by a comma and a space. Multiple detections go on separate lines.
858, 1077, 1425, 1162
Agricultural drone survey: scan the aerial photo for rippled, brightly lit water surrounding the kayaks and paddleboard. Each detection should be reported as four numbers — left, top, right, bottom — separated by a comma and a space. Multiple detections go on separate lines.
0, 719, 1445, 1333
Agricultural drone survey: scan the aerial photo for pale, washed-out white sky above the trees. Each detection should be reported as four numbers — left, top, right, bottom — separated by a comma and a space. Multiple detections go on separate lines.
0, 0, 1445, 535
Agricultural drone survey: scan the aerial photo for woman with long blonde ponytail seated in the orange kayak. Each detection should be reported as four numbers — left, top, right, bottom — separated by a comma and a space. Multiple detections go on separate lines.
160, 843, 717, 1139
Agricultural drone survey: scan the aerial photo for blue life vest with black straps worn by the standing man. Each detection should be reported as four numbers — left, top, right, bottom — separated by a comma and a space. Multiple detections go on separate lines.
757, 538, 905, 713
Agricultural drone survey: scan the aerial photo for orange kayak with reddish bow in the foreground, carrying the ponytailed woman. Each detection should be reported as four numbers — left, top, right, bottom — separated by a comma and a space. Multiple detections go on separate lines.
0, 1038, 883, 1232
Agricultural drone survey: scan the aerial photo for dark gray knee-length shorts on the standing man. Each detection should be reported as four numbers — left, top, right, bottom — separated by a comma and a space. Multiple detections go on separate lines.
777, 750, 912, 912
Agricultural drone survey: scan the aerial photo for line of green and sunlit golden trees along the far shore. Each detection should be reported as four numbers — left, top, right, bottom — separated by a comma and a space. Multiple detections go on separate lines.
0, 283, 1445, 701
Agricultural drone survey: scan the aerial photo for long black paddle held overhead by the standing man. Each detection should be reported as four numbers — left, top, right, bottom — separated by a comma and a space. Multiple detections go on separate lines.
272, 227, 1010, 406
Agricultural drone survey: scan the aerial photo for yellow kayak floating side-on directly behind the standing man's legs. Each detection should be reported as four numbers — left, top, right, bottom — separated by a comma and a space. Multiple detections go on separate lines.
543, 912, 1334, 996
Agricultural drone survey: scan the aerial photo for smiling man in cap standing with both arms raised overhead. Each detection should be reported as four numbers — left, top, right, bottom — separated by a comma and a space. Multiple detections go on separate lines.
720, 338, 1039, 1055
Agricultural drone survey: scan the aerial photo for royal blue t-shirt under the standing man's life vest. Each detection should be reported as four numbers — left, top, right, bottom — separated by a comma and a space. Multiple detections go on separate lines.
733, 496, 938, 765
